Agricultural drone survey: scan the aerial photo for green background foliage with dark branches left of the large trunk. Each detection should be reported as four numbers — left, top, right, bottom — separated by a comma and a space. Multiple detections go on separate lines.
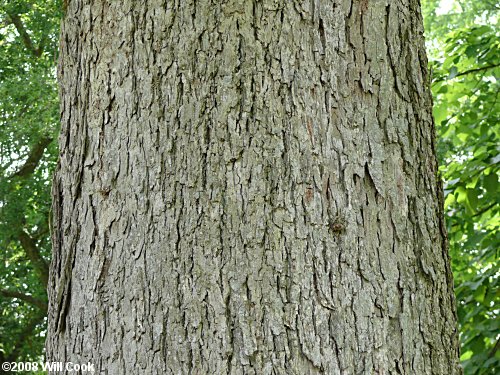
0, 1, 59, 362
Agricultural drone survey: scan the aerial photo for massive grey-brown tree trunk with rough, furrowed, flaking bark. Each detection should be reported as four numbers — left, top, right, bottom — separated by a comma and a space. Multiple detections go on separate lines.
47, 0, 461, 375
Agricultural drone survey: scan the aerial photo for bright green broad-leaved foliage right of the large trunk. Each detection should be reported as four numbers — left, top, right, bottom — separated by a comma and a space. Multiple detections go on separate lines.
424, 0, 500, 374
